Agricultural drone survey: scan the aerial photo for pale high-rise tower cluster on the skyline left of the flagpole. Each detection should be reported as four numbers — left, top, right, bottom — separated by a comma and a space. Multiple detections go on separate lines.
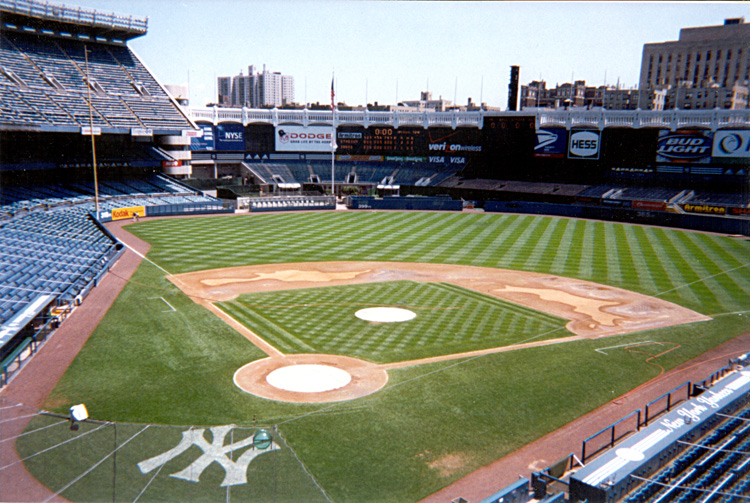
217, 65, 294, 108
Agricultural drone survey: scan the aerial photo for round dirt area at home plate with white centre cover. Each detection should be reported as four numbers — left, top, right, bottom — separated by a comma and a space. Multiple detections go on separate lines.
234, 354, 388, 403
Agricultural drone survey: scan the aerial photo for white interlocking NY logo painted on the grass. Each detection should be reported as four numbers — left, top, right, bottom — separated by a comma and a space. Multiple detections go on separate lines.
138, 426, 279, 487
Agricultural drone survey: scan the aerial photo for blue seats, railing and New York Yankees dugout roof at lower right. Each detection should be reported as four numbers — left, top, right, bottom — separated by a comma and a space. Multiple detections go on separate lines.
472, 364, 750, 503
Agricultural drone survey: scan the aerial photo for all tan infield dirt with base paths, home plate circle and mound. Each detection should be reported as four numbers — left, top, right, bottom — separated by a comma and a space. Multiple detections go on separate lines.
168, 262, 710, 403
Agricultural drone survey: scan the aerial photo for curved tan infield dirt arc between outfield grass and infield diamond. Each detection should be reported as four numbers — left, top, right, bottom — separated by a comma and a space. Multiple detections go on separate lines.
169, 262, 710, 338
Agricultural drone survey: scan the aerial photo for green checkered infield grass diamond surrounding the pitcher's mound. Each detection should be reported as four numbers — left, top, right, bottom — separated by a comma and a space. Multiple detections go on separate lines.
219, 281, 566, 362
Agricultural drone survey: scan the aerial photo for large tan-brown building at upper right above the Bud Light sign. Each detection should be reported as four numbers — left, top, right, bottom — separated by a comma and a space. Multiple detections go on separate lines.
639, 18, 750, 108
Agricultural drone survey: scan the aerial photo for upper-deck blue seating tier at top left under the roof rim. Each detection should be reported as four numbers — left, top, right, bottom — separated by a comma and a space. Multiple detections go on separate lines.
0, 29, 192, 132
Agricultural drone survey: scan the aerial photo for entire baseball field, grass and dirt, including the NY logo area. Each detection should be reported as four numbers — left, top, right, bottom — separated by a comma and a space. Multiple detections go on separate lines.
17, 212, 750, 502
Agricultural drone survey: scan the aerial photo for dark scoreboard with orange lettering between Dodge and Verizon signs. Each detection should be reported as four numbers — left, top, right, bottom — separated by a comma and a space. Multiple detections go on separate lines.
336, 126, 427, 156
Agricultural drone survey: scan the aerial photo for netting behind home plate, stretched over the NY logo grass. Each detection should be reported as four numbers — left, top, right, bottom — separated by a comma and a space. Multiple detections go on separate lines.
0, 413, 328, 503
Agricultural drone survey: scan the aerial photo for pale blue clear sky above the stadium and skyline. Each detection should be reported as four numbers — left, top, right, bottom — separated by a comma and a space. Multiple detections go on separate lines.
79, 0, 750, 109
